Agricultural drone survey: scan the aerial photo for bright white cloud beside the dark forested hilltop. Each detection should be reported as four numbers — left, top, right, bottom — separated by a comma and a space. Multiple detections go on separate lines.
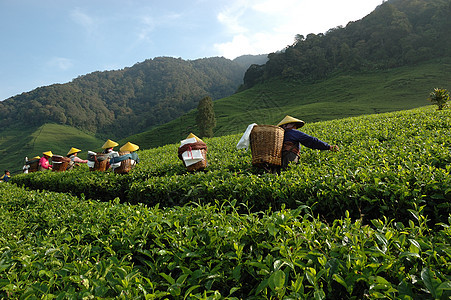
214, 0, 382, 58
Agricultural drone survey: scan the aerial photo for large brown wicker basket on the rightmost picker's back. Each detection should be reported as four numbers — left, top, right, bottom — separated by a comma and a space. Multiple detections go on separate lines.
250, 125, 284, 166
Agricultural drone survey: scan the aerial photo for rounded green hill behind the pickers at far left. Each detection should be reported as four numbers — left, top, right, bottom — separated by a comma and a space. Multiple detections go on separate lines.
0, 124, 104, 172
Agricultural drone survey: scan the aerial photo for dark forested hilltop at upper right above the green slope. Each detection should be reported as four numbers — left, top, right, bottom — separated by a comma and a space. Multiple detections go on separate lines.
241, 0, 451, 90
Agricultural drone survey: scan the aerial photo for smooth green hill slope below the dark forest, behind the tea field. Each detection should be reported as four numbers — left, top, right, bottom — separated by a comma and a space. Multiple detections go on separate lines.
123, 59, 451, 149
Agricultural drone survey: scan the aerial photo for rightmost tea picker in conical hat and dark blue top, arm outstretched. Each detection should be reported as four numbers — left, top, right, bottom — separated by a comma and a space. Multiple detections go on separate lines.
277, 115, 338, 169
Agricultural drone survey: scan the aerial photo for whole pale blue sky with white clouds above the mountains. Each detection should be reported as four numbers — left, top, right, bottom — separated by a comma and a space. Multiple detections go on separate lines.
0, 0, 382, 100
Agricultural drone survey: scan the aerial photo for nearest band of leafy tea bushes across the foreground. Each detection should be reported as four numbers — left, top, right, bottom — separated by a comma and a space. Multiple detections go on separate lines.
0, 184, 451, 299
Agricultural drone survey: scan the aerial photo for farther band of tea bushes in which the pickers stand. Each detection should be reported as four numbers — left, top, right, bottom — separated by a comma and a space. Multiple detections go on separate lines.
12, 107, 451, 224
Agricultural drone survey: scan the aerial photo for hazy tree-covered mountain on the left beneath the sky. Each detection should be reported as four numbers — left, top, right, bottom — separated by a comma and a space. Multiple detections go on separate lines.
0, 55, 266, 138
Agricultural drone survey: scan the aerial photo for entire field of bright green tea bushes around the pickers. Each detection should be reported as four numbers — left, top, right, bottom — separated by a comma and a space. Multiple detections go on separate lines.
0, 106, 451, 299
